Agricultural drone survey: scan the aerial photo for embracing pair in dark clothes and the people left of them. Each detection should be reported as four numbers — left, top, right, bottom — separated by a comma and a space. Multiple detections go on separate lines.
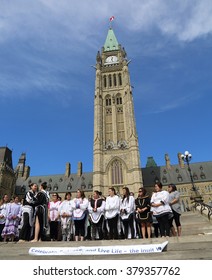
0, 182, 50, 242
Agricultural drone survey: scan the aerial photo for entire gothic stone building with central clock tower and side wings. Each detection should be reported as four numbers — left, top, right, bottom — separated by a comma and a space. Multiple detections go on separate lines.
0, 28, 212, 210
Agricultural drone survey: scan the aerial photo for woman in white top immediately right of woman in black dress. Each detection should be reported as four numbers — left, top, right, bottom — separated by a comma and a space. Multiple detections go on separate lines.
151, 182, 172, 237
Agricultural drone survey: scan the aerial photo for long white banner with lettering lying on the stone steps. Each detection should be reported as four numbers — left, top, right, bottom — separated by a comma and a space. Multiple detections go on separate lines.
29, 241, 168, 256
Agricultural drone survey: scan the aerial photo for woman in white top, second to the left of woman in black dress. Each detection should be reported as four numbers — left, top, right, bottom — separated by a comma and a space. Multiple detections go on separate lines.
105, 188, 120, 239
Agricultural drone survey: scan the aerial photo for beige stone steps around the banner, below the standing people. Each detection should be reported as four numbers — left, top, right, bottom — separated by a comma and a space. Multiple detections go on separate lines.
0, 211, 212, 260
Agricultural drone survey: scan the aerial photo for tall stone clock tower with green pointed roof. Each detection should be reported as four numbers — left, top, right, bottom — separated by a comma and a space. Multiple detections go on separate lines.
93, 28, 143, 194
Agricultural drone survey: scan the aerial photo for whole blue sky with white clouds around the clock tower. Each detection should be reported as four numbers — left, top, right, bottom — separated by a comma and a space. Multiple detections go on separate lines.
0, 0, 212, 175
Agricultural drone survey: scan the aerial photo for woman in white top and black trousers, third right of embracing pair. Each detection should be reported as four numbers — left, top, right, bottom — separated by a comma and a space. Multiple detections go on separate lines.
72, 190, 88, 241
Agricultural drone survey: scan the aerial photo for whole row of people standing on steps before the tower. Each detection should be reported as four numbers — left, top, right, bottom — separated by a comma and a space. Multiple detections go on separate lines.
0, 182, 181, 242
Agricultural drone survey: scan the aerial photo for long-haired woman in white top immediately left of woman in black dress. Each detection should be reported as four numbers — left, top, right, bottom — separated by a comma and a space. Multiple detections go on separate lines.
120, 187, 135, 239
